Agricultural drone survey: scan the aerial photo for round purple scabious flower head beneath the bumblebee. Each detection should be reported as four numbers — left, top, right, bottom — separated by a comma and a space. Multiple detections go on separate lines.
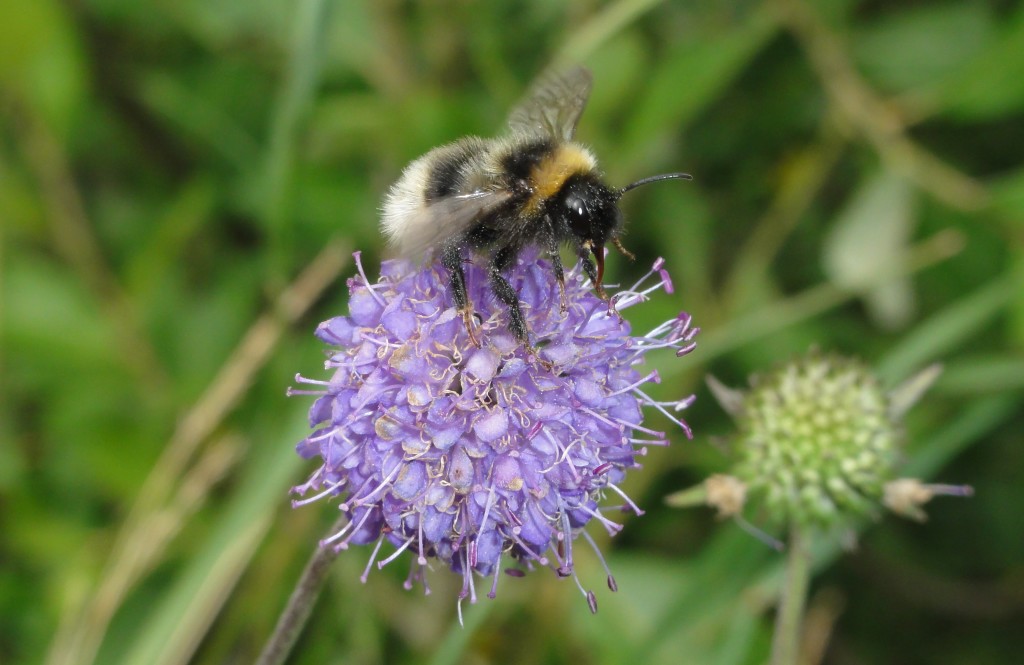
292, 252, 697, 611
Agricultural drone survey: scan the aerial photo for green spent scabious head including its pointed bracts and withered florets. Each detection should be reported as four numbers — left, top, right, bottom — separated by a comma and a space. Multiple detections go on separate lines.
692, 352, 970, 528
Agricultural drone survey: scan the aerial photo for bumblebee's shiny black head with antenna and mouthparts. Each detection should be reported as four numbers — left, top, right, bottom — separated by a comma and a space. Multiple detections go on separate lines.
554, 173, 691, 291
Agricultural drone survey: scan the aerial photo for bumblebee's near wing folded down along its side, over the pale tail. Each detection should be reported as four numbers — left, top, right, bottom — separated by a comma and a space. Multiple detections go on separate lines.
384, 190, 511, 258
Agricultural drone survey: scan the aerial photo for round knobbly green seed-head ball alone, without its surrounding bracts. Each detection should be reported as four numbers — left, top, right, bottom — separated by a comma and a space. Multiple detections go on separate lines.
728, 352, 899, 527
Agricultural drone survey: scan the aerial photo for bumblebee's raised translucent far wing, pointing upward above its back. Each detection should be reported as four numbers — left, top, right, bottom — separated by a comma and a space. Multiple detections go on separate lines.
509, 67, 593, 140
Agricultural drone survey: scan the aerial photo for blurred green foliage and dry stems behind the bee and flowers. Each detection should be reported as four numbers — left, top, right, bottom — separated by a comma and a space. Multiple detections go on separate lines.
0, 0, 1024, 665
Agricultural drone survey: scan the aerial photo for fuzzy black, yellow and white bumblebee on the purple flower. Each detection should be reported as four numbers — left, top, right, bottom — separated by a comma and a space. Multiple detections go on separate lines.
381, 68, 690, 345
